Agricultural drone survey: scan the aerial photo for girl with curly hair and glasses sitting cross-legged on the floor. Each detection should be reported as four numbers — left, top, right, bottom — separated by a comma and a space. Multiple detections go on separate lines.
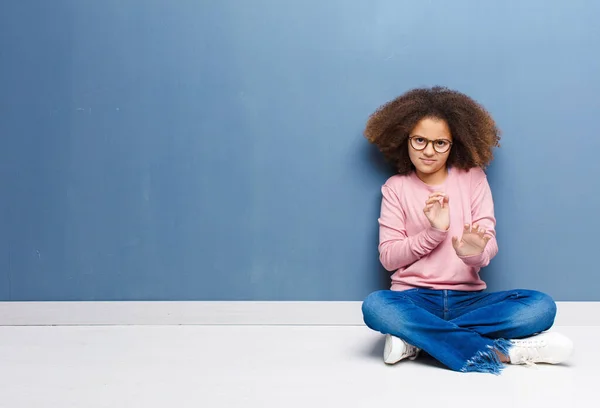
362, 87, 573, 374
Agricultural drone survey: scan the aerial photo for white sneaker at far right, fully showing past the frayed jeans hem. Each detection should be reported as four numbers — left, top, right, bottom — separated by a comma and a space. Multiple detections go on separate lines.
508, 332, 573, 365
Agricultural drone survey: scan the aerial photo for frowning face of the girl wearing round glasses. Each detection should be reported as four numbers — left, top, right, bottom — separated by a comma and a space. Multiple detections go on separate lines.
408, 118, 452, 184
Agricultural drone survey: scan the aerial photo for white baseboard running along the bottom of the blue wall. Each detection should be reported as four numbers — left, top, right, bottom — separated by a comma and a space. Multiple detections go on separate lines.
0, 301, 600, 326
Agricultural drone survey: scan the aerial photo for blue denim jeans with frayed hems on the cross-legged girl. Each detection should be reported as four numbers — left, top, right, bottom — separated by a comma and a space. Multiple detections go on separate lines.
362, 288, 556, 374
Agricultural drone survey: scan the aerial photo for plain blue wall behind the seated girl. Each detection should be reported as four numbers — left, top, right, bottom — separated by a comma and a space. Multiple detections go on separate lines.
0, 0, 600, 300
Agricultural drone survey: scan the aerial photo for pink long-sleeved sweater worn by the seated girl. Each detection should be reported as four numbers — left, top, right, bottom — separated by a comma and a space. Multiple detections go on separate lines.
379, 168, 498, 291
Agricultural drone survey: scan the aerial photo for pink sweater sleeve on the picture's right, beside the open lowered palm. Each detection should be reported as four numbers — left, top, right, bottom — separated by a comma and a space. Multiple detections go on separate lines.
460, 171, 498, 268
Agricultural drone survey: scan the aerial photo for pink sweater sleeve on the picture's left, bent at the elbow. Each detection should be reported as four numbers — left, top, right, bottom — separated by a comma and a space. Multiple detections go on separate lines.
379, 185, 448, 271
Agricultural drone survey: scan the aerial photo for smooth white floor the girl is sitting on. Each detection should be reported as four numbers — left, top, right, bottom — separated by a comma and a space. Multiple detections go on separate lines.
0, 326, 600, 408
